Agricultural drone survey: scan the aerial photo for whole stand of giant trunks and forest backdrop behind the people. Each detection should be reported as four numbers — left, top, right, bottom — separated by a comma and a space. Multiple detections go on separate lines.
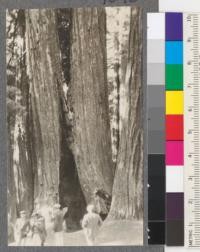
6, 7, 143, 230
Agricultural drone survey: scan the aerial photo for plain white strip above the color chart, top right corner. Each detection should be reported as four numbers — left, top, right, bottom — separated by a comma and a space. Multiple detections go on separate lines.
159, 0, 200, 12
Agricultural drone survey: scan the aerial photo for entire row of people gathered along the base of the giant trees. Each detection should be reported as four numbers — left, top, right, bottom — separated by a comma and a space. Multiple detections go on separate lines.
8, 191, 110, 246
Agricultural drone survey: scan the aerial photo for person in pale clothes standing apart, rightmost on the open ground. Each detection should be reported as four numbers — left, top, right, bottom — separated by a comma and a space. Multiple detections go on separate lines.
82, 205, 102, 246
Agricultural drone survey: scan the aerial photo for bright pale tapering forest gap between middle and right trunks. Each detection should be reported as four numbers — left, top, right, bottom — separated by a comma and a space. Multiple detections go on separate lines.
106, 6, 131, 163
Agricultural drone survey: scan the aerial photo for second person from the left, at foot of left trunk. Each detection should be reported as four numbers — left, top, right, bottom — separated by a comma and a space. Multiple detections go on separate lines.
30, 212, 47, 246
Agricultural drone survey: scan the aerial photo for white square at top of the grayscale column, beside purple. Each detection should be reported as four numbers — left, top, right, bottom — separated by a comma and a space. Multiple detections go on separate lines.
147, 13, 165, 40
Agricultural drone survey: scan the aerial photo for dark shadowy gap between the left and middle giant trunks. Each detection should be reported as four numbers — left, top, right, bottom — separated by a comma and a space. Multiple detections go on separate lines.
56, 9, 86, 232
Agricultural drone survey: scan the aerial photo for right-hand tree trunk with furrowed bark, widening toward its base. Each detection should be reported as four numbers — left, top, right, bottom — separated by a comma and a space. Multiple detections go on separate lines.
109, 8, 143, 219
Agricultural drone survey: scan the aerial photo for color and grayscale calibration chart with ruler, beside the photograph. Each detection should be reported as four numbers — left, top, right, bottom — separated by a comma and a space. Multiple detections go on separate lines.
147, 13, 200, 247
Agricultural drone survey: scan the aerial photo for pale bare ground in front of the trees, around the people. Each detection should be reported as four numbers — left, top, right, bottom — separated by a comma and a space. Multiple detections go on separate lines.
11, 221, 143, 246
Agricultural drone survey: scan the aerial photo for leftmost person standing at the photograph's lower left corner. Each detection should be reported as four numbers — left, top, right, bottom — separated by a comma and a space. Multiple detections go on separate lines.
15, 211, 30, 246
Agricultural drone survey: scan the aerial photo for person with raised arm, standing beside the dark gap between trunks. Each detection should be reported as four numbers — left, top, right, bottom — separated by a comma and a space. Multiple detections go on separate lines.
52, 204, 67, 246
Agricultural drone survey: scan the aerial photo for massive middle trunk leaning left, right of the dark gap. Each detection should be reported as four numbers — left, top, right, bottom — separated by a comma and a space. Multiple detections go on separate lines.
70, 8, 114, 202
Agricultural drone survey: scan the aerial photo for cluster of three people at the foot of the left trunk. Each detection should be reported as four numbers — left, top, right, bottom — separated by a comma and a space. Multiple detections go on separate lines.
8, 204, 67, 246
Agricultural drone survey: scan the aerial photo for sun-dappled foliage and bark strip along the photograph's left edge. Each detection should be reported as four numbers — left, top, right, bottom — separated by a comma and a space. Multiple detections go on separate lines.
7, 10, 33, 220
